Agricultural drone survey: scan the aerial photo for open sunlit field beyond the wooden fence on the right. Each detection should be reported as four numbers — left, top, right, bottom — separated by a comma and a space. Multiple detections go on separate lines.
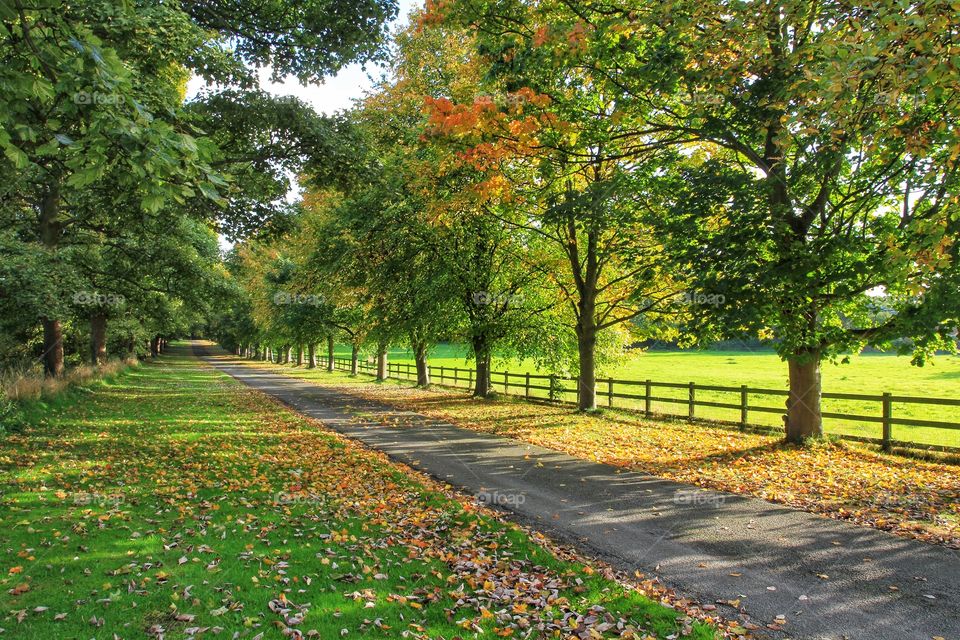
337, 345, 960, 450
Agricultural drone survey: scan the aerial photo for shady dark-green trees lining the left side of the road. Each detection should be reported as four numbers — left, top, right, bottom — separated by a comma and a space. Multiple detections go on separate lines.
0, 0, 396, 376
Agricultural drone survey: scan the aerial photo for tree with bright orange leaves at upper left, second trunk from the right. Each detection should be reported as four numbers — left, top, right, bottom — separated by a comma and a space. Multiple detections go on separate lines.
429, 1, 679, 410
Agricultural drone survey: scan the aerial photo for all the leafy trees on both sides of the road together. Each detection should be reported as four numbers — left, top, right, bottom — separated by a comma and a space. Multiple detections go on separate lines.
0, 0, 960, 441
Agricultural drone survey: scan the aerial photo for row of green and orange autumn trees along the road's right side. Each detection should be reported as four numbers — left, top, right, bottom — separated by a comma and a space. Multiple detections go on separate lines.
221, 0, 960, 442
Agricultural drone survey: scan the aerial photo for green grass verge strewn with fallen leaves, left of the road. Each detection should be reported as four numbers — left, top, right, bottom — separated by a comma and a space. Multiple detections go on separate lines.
0, 351, 715, 640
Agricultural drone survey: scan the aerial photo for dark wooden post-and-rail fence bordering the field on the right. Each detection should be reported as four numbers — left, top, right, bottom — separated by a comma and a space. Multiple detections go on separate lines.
326, 358, 960, 452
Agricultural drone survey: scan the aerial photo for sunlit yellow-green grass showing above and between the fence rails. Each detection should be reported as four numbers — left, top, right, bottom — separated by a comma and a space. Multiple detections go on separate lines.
337, 344, 960, 447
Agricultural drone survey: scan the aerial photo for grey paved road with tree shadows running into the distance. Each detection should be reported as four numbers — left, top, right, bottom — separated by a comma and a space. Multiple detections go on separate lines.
197, 347, 960, 640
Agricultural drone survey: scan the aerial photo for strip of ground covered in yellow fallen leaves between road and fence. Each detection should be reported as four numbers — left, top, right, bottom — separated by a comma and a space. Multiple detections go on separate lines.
292, 369, 960, 548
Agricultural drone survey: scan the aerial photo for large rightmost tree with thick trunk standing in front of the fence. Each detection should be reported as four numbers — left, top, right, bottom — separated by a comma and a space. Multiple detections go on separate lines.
536, 1, 960, 442
